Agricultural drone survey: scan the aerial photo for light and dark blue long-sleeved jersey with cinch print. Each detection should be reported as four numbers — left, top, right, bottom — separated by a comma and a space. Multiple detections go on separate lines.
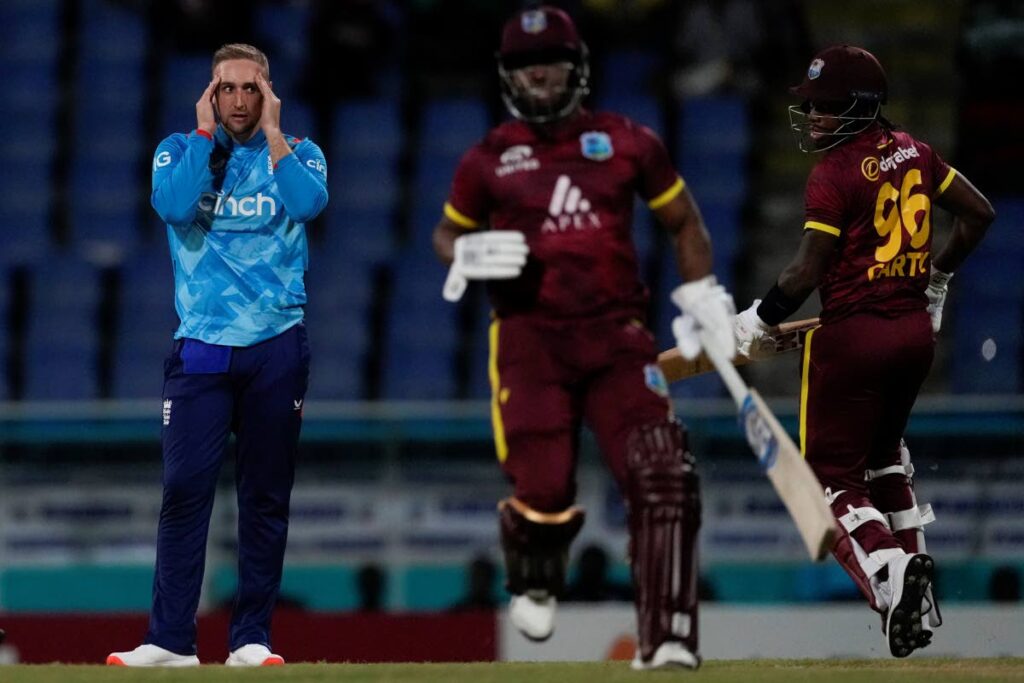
152, 126, 328, 346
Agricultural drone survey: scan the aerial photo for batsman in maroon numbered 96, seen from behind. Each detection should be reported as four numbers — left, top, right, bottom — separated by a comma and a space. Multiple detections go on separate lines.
735, 45, 994, 657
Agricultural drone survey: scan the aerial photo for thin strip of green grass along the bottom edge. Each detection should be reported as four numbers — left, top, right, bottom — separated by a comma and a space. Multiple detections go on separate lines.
6, 658, 1024, 683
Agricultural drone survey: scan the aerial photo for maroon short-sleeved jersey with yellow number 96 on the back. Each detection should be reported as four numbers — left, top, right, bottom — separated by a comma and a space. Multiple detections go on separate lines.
804, 126, 956, 321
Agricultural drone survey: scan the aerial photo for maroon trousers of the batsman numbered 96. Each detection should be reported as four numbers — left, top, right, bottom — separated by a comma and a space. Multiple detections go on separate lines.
800, 309, 935, 593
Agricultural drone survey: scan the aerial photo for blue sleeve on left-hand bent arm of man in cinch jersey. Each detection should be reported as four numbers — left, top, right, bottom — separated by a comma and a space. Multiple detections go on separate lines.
150, 133, 213, 225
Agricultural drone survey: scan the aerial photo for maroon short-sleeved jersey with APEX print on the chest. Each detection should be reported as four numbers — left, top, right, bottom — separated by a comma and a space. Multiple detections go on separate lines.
444, 112, 683, 318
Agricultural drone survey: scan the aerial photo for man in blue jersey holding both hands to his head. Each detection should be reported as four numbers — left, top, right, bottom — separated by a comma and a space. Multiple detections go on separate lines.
106, 44, 328, 667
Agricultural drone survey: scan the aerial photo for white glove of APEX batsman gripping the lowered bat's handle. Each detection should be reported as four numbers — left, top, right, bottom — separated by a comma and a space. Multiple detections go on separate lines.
672, 275, 736, 360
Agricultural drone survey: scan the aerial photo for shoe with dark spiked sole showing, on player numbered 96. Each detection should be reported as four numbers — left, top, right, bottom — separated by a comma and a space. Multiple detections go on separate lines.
884, 553, 935, 657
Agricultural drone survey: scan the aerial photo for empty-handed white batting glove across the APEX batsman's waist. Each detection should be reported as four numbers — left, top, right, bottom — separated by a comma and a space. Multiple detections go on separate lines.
443, 230, 529, 301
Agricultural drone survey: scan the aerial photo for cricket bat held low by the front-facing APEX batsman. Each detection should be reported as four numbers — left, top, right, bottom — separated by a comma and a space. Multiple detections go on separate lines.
700, 335, 837, 562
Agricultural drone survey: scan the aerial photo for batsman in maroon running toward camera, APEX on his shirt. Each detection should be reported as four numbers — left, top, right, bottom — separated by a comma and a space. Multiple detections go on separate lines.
434, 7, 735, 669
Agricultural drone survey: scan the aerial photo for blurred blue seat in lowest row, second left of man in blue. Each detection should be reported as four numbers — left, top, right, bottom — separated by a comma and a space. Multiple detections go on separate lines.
25, 255, 99, 400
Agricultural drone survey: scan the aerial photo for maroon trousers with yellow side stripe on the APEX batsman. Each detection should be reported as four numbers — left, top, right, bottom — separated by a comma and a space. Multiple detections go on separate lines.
489, 316, 672, 512
